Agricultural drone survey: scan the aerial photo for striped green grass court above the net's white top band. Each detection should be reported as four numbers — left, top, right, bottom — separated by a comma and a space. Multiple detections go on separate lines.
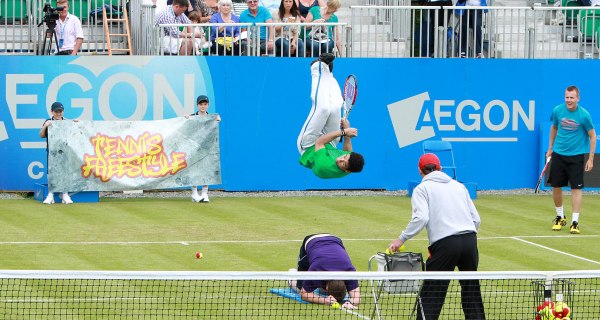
0, 195, 600, 271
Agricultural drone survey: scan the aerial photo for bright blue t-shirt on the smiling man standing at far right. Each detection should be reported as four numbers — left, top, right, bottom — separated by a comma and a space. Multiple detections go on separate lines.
550, 103, 594, 156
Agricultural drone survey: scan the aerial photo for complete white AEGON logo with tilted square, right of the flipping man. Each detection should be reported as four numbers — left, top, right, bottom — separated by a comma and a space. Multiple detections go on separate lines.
388, 92, 535, 148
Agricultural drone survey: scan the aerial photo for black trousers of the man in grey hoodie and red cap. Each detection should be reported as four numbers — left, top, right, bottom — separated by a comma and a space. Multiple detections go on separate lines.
417, 233, 485, 320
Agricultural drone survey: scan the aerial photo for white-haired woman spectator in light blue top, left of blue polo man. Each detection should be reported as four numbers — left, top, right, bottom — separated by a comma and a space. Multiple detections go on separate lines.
210, 0, 245, 56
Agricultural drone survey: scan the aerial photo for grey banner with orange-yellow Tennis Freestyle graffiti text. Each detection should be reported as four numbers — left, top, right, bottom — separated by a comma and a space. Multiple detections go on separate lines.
48, 114, 221, 192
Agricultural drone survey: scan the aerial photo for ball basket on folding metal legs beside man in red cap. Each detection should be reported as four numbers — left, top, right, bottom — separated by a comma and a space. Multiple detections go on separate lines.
368, 252, 425, 319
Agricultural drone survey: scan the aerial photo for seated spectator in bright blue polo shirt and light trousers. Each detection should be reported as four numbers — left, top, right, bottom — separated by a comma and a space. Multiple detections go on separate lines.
240, 0, 275, 55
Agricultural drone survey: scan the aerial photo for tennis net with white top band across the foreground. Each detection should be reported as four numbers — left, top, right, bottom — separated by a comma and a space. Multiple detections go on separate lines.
0, 270, 600, 320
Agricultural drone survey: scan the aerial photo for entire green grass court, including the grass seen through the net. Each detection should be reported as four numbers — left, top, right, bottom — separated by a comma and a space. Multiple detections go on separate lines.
0, 194, 600, 319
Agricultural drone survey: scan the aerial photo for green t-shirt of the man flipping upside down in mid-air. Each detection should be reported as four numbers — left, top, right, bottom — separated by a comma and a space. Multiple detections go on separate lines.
300, 143, 350, 179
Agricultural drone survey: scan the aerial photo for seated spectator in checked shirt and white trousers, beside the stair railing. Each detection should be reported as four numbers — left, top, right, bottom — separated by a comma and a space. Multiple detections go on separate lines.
154, 0, 194, 55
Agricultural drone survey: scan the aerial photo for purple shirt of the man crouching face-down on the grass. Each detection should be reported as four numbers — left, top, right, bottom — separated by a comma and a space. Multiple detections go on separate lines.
302, 236, 358, 292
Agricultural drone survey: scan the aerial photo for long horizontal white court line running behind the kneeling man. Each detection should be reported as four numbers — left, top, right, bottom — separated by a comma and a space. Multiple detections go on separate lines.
0, 235, 600, 246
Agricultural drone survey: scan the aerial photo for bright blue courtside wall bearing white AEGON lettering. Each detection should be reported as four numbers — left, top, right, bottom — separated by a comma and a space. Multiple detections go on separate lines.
0, 56, 600, 191
